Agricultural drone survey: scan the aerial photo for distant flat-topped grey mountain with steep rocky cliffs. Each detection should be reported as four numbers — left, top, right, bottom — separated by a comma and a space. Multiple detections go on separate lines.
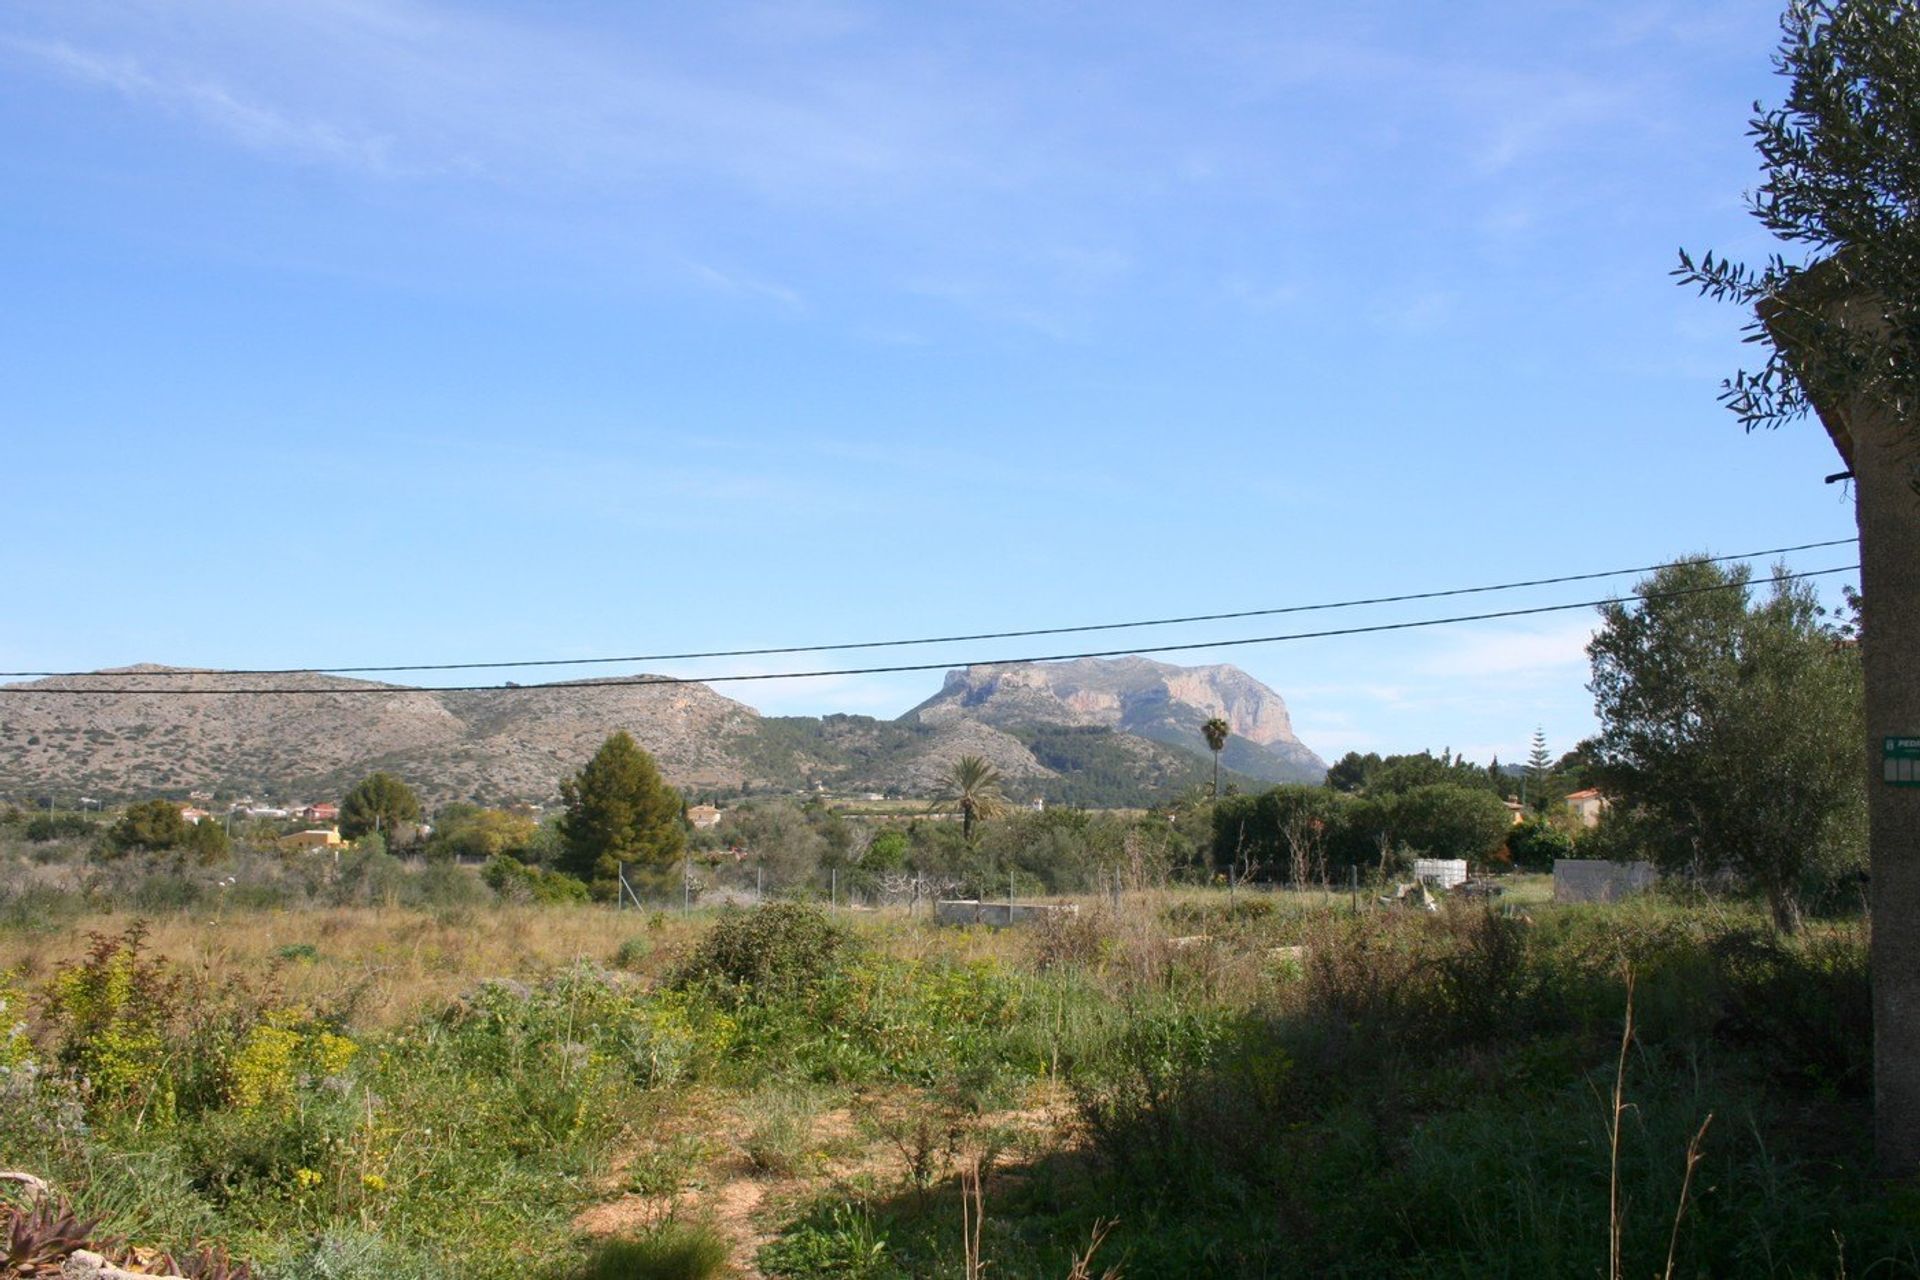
908, 658, 1327, 783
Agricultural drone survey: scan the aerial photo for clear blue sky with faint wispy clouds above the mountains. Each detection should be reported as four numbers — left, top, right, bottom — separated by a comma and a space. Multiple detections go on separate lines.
0, 0, 1853, 771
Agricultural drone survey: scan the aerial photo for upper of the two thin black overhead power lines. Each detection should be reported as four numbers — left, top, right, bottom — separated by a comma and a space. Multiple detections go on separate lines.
0, 537, 1860, 687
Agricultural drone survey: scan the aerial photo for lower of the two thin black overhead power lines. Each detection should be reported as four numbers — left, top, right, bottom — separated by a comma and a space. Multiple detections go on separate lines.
0, 564, 1860, 697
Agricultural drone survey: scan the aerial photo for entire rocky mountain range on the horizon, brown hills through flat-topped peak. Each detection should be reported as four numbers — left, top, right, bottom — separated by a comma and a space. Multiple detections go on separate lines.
0, 662, 1323, 804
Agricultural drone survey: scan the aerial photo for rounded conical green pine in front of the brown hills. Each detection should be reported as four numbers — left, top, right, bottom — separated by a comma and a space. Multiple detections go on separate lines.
559, 731, 687, 898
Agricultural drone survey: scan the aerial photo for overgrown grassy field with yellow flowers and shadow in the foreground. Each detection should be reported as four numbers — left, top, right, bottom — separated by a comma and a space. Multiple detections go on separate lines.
0, 892, 1920, 1280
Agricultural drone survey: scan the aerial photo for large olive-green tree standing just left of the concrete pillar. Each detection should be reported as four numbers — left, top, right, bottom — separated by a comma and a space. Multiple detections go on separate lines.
1588, 558, 1864, 931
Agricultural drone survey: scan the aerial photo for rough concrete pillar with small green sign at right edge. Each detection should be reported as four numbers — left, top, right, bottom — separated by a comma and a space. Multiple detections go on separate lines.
1761, 282, 1920, 1174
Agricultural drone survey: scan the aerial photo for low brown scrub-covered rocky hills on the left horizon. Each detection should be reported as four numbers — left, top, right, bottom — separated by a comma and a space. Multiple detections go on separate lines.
0, 666, 760, 798
